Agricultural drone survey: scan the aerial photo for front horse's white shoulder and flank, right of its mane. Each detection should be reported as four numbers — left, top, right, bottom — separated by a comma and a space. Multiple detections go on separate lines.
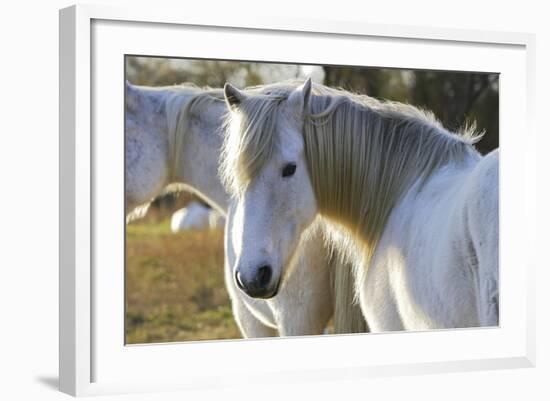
359, 154, 498, 331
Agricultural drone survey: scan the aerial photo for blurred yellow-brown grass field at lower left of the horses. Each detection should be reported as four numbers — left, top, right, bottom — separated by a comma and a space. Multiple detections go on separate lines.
126, 202, 241, 344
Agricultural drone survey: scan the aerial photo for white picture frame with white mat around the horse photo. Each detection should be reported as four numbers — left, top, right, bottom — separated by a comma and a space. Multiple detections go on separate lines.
59, 5, 536, 396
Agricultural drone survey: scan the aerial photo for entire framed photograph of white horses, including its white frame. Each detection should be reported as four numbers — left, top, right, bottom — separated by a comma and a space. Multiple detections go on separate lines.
60, 6, 535, 396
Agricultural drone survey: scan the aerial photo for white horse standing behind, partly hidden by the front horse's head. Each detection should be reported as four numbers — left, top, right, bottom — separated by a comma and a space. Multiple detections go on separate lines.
126, 84, 366, 337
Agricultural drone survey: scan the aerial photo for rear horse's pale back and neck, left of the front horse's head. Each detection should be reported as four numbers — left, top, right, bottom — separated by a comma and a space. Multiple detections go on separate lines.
125, 84, 228, 219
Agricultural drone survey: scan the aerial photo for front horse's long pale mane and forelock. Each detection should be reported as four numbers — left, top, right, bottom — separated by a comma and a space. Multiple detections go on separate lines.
221, 79, 481, 261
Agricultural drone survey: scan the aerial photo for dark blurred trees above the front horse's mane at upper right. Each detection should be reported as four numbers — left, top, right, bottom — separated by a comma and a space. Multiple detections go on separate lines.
324, 66, 499, 154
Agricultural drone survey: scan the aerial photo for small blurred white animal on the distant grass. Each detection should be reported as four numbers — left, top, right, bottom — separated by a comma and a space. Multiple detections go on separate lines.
170, 201, 225, 233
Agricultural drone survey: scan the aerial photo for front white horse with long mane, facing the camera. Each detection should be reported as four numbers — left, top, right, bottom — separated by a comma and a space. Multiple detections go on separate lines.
221, 80, 499, 332
